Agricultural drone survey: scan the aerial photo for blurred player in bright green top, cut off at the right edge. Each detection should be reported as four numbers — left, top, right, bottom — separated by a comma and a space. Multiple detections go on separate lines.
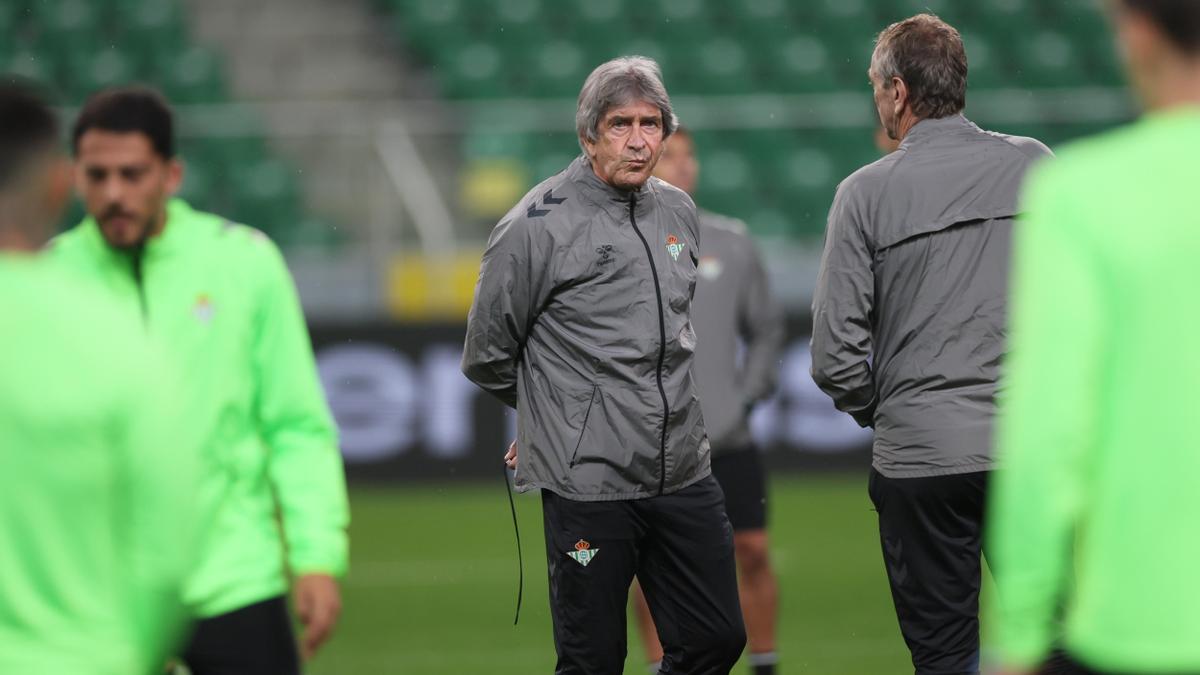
989, 0, 1200, 674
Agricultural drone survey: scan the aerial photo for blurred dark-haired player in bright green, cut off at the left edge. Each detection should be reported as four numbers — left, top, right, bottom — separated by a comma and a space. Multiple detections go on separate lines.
0, 78, 199, 675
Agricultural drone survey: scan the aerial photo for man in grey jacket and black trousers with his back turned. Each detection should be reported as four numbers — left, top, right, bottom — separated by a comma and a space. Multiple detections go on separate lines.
812, 14, 1050, 674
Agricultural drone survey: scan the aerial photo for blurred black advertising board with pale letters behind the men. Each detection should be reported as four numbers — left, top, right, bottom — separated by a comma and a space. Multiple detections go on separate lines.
310, 318, 871, 480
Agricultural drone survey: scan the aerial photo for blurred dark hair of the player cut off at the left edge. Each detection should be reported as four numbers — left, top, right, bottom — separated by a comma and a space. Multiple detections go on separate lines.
0, 76, 59, 190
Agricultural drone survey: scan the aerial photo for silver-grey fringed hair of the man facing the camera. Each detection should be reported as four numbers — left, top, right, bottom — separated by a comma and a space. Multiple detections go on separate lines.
575, 56, 679, 151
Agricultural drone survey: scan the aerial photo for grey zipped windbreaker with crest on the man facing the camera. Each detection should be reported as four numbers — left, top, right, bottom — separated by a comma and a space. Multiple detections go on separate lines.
462, 156, 709, 501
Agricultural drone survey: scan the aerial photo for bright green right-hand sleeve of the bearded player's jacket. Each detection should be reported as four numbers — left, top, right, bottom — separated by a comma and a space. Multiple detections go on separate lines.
254, 241, 349, 575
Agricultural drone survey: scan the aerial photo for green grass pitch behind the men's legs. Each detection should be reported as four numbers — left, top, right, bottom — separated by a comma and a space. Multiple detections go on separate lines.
306, 471, 969, 675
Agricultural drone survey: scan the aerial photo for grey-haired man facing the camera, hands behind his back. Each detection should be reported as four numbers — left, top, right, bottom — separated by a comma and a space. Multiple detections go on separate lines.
462, 56, 745, 675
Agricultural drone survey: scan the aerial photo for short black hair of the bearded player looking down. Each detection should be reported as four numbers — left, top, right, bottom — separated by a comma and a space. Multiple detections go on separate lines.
71, 85, 175, 160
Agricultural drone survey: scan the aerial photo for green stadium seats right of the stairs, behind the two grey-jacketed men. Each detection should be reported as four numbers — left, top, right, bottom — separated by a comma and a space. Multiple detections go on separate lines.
376, 0, 1120, 238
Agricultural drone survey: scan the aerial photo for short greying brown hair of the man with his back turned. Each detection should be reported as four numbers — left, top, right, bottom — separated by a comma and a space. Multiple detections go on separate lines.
871, 14, 967, 119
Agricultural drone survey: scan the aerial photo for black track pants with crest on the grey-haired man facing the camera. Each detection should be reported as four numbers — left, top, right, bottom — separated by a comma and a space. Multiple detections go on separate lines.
542, 477, 745, 675
